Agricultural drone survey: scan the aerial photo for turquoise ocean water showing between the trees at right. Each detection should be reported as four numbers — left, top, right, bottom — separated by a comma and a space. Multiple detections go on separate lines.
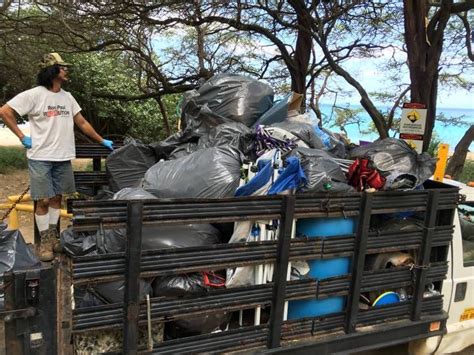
321, 104, 474, 152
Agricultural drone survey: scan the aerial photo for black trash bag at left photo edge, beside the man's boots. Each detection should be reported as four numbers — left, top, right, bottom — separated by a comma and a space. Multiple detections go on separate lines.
0, 223, 41, 275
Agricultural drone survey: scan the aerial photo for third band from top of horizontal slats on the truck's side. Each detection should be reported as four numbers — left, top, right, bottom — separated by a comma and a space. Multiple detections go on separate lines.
73, 262, 448, 332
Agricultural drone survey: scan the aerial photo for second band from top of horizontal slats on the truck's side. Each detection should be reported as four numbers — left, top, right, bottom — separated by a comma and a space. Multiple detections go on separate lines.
67, 226, 453, 285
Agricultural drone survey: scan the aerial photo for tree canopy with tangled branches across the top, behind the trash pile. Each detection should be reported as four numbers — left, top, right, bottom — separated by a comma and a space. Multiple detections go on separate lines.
1, 0, 473, 152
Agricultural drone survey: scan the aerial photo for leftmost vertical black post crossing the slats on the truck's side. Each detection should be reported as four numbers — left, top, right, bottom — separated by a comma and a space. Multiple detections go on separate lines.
123, 201, 143, 355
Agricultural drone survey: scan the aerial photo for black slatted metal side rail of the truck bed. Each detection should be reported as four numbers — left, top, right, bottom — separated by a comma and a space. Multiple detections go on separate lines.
62, 183, 458, 353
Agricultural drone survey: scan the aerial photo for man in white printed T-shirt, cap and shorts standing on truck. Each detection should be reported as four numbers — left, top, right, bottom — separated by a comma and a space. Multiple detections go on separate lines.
0, 53, 113, 261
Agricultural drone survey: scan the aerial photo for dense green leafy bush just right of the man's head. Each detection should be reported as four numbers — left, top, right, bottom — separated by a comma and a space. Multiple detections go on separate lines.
66, 53, 177, 142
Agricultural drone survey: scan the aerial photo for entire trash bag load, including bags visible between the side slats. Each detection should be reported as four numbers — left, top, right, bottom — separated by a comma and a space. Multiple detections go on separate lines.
69, 74, 436, 338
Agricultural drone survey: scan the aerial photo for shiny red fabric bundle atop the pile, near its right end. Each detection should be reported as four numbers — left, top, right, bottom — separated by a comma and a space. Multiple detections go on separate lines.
347, 159, 386, 191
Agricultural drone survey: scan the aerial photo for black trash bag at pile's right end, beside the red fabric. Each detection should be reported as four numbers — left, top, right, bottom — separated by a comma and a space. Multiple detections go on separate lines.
350, 138, 436, 190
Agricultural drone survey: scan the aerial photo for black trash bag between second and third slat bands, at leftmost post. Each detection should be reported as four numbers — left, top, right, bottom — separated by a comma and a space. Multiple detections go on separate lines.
74, 280, 152, 308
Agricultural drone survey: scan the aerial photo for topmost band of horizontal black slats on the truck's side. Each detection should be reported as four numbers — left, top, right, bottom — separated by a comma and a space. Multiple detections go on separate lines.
72, 184, 458, 231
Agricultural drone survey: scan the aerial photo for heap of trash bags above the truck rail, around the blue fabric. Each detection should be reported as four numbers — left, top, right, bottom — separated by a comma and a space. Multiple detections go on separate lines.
106, 74, 436, 198
